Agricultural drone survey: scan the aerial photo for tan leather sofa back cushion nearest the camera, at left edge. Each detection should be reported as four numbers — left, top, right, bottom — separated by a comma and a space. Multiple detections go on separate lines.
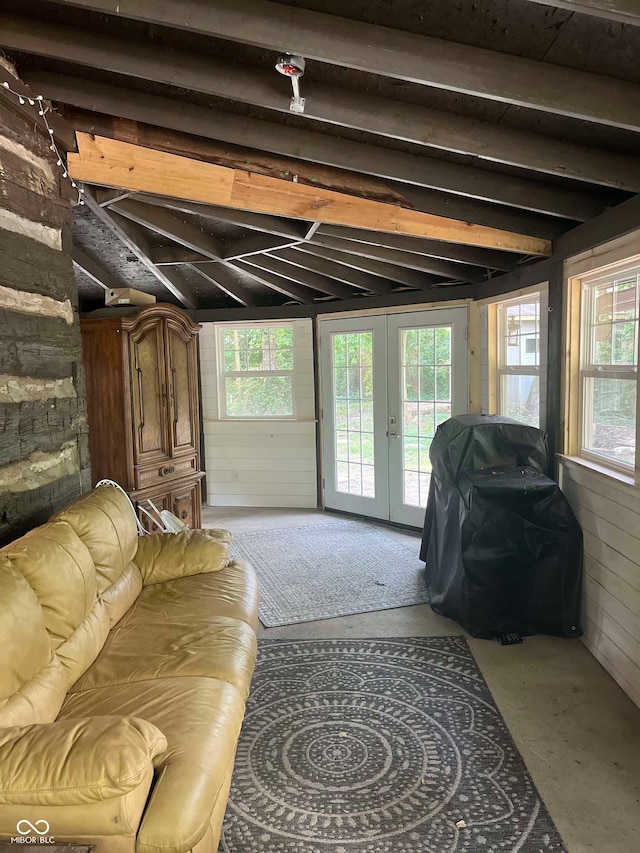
0, 554, 52, 701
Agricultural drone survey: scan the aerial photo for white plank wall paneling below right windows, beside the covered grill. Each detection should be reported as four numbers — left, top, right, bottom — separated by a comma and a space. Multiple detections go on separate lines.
560, 460, 640, 706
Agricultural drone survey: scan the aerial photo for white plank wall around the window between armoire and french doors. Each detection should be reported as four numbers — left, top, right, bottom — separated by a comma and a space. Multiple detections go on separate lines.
199, 319, 318, 508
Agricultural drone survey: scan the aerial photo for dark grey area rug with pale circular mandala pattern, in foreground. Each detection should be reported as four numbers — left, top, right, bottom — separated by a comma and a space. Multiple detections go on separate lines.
220, 637, 566, 853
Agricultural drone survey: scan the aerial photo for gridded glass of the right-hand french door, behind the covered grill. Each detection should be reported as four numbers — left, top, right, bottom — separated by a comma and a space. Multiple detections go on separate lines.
400, 326, 452, 507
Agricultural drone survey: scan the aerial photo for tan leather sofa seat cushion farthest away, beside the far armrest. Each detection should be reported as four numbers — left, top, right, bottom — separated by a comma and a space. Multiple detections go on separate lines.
123, 560, 258, 630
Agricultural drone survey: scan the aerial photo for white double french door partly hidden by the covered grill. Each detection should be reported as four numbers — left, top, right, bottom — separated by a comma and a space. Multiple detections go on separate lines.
320, 308, 468, 527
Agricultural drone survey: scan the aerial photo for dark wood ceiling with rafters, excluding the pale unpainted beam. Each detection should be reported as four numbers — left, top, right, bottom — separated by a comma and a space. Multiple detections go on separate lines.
0, 0, 640, 309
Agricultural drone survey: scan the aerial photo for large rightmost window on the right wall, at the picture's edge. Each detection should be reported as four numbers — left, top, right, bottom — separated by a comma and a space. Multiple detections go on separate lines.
580, 268, 640, 469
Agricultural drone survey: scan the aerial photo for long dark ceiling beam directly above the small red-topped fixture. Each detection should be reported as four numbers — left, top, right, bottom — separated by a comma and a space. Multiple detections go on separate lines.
42, 0, 640, 130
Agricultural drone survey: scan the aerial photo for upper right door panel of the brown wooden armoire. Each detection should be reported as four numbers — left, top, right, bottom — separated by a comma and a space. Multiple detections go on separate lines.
167, 320, 198, 456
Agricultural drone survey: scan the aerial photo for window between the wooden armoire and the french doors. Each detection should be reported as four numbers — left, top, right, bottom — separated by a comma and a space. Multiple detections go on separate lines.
217, 323, 295, 418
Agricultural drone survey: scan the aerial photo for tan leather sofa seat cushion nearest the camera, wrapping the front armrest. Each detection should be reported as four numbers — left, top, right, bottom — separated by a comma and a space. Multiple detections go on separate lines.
60, 678, 244, 853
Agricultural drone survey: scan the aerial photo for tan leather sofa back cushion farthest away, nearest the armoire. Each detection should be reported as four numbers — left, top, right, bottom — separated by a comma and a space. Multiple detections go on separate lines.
54, 486, 138, 596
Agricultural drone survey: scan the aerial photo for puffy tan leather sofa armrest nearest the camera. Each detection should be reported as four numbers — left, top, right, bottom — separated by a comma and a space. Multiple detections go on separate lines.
0, 717, 167, 808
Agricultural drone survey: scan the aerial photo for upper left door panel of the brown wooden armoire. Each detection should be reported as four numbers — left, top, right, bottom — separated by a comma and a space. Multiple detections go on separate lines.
129, 321, 171, 465
